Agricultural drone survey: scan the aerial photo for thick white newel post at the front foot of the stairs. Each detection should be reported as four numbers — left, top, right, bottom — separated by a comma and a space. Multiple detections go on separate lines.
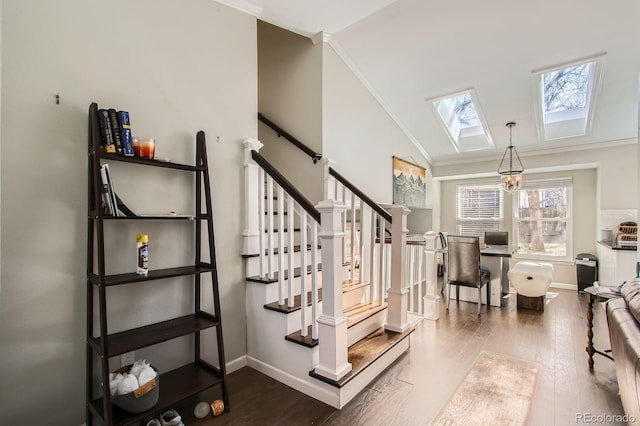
315, 200, 351, 380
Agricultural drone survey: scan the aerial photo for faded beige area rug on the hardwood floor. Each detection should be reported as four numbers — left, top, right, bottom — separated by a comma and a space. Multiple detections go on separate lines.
431, 351, 540, 426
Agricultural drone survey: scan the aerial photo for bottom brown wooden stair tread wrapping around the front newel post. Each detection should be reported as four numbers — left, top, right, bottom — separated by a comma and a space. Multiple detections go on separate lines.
309, 327, 415, 388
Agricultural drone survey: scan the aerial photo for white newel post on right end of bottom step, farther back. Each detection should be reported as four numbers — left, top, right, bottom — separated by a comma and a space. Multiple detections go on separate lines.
384, 206, 411, 333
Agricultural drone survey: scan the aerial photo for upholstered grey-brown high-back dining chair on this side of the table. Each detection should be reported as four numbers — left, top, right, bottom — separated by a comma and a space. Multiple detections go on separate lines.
447, 235, 491, 315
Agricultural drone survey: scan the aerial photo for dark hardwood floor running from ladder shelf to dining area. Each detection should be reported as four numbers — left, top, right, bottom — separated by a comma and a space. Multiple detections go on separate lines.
175, 288, 623, 426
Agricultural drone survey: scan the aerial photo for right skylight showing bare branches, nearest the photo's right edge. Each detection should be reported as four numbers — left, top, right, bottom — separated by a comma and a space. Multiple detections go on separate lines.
533, 57, 602, 140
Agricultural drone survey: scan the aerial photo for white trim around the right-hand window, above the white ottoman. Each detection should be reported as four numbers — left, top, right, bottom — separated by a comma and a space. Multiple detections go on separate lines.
511, 176, 574, 263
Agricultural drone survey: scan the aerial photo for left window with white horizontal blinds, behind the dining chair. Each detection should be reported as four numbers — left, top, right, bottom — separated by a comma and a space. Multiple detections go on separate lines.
456, 185, 503, 241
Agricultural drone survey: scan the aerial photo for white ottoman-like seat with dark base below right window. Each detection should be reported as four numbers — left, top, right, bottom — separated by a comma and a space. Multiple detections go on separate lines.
508, 261, 553, 311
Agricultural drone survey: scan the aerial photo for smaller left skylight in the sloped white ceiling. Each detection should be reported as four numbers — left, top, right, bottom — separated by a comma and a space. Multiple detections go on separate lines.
429, 89, 494, 152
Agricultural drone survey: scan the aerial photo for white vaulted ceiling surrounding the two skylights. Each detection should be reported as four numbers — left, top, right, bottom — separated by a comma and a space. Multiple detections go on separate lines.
218, 0, 640, 165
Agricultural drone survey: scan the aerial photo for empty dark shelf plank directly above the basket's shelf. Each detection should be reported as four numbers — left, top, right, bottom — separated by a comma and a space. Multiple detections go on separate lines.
89, 311, 220, 357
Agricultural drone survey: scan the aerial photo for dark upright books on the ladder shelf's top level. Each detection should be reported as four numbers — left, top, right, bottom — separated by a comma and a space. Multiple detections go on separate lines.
98, 108, 134, 156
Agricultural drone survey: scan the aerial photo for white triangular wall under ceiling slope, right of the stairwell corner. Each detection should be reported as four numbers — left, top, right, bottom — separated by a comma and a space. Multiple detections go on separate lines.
322, 43, 433, 216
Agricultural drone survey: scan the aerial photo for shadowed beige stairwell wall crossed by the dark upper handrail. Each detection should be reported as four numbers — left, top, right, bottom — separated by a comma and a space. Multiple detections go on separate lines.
258, 21, 323, 203
